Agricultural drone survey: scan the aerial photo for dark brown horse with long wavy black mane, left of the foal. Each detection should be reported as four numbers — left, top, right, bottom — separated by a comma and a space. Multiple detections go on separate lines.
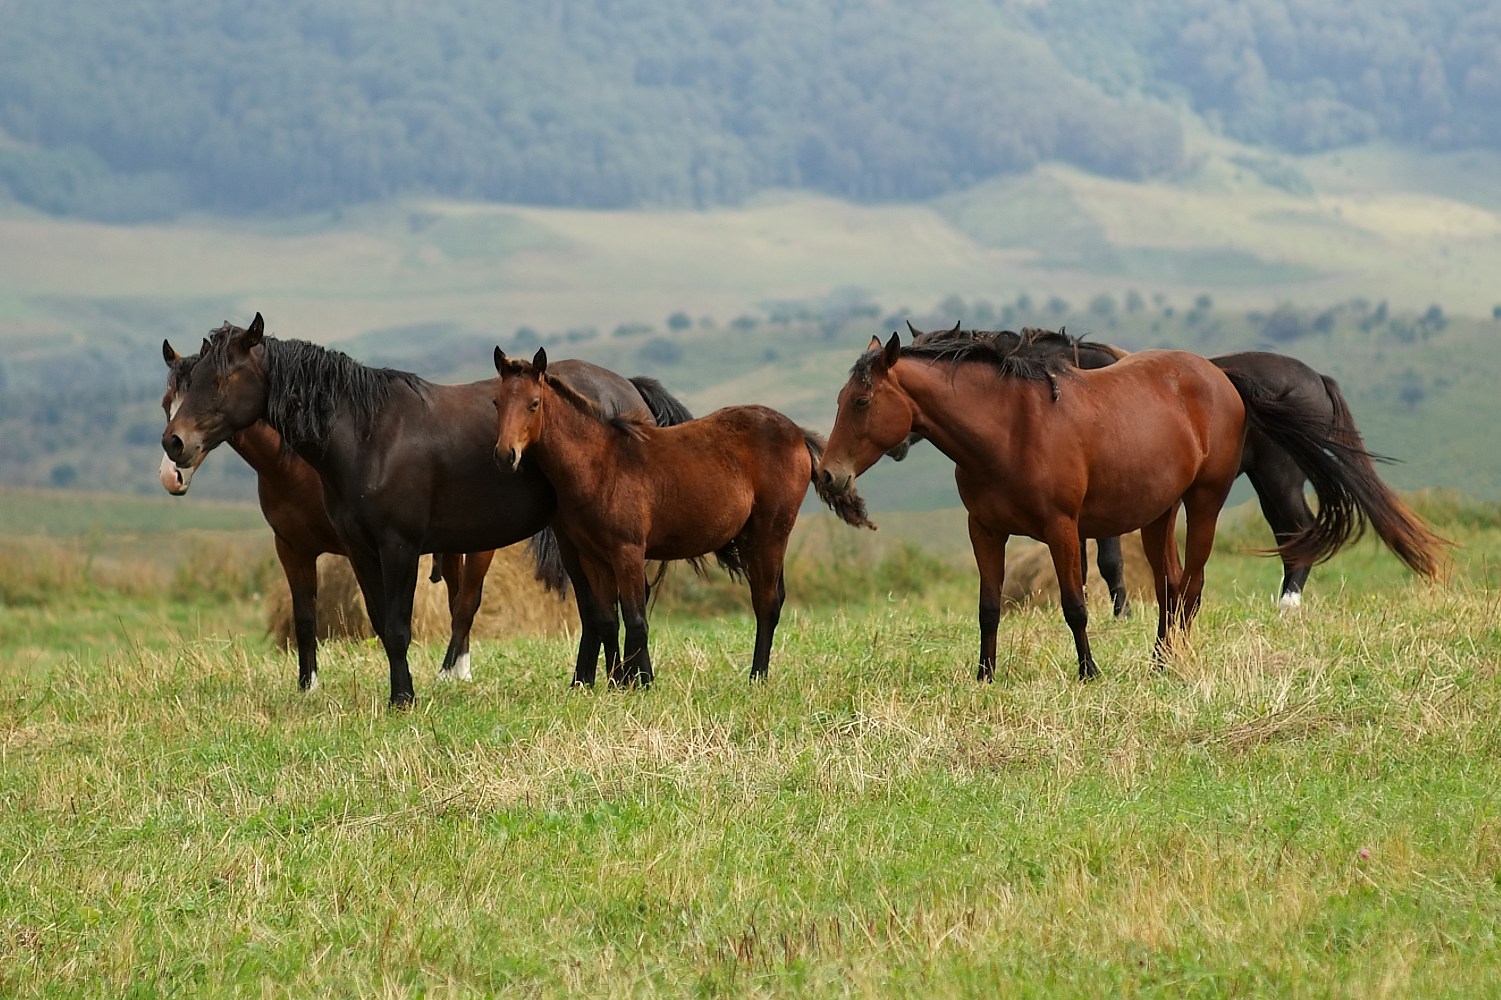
162, 312, 686, 707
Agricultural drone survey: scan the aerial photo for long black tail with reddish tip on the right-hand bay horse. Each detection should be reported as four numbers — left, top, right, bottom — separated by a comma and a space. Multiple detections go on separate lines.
1225, 371, 1448, 577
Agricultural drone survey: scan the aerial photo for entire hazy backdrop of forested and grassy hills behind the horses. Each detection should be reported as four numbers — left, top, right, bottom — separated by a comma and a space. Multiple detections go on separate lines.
0, 0, 1501, 508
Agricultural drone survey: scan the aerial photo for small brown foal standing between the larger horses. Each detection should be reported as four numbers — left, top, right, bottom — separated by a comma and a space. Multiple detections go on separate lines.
491, 347, 875, 686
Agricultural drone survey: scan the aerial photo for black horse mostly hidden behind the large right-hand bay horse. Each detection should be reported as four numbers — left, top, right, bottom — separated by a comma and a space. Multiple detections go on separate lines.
894, 323, 1421, 614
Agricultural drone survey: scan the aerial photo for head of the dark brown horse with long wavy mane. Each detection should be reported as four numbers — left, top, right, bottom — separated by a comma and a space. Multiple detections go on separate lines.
162, 312, 267, 480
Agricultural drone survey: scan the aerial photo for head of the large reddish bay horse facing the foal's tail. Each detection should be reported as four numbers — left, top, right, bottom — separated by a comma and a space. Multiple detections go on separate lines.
818, 333, 913, 494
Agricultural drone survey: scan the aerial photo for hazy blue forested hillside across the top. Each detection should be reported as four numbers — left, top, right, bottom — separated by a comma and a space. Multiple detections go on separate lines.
0, 0, 1501, 219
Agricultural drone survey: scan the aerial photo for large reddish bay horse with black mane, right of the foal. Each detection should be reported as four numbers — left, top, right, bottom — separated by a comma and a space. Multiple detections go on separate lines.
818, 333, 1442, 680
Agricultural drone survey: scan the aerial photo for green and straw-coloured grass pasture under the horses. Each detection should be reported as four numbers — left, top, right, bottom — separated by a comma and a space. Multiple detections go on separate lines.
0, 497, 1501, 997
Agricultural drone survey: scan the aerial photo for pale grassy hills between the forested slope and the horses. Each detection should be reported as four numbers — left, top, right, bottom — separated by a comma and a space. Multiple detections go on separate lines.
0, 135, 1501, 509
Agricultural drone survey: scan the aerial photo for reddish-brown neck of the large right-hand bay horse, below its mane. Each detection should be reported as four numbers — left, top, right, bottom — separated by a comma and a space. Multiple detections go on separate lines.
892, 360, 1049, 465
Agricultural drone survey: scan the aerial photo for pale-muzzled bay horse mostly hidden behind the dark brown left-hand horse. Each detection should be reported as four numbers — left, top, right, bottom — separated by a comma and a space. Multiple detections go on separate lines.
159, 341, 498, 691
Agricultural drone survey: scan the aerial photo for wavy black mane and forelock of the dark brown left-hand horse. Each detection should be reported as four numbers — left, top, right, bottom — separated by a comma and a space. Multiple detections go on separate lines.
196, 323, 429, 444
